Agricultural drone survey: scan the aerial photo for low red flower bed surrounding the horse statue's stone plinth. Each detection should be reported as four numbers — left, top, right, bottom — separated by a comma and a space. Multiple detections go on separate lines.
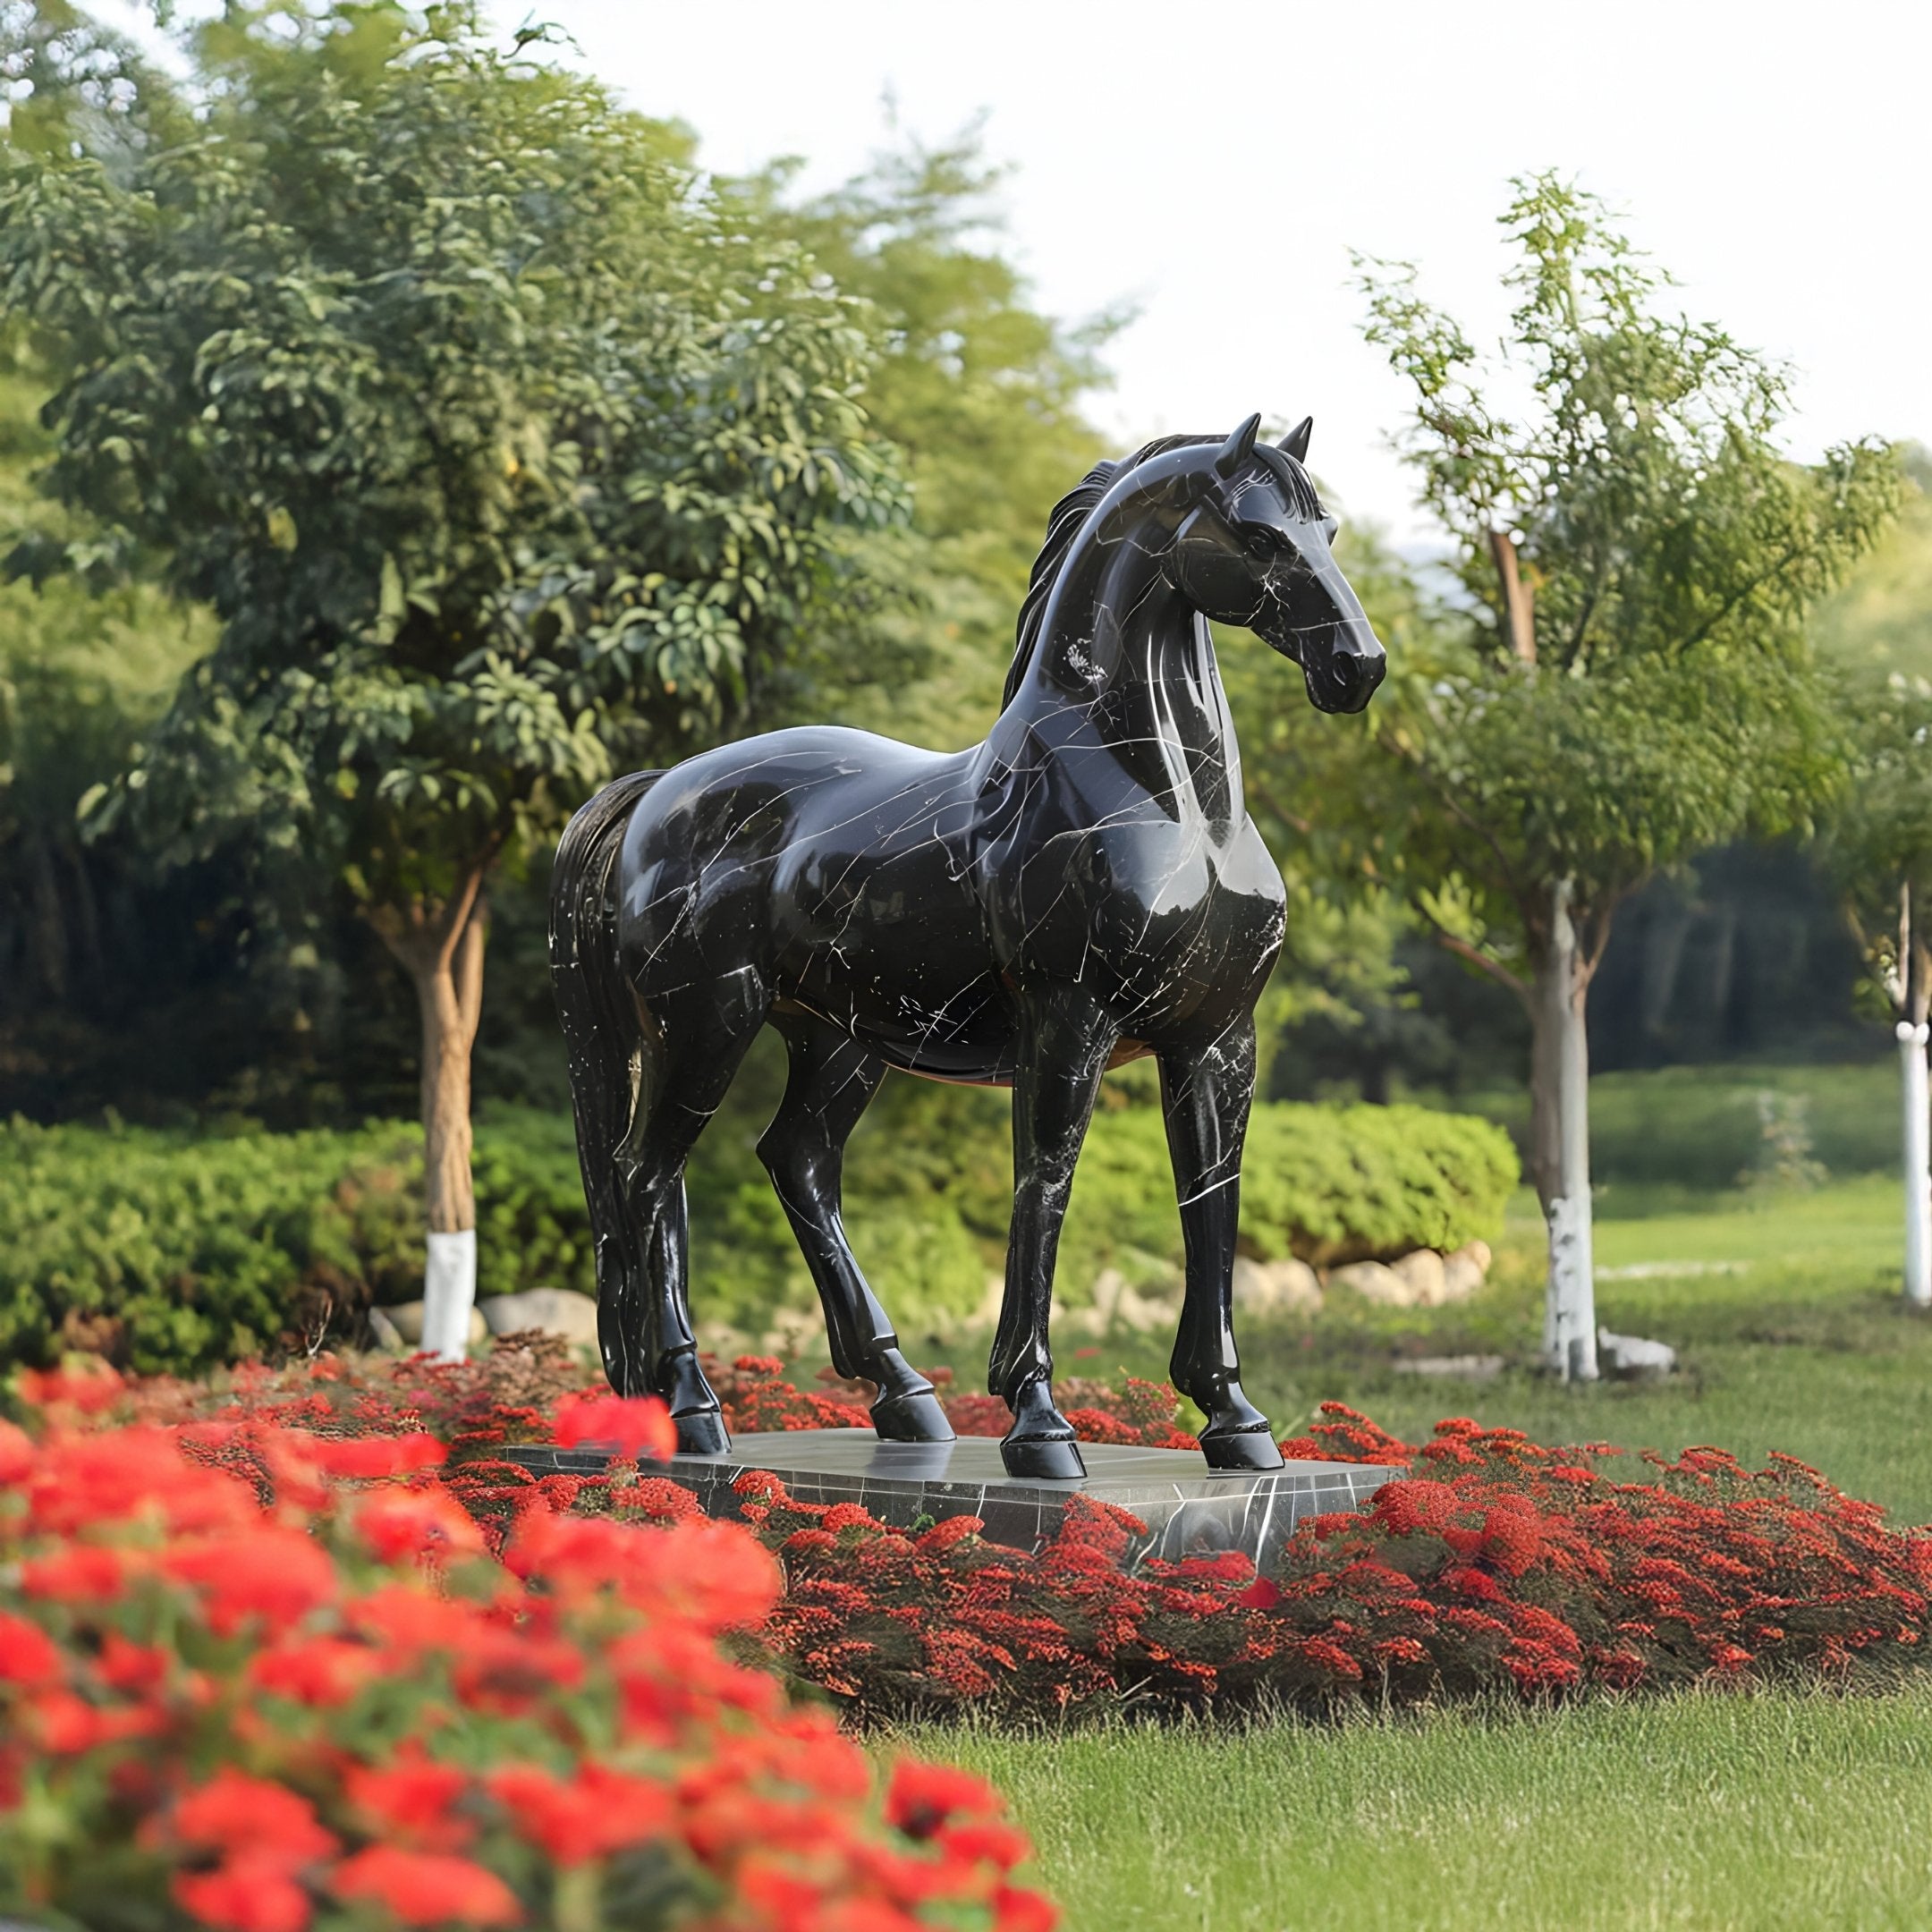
14, 1349, 1932, 1754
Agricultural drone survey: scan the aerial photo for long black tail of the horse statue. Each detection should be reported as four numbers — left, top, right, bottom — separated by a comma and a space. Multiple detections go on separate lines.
551, 771, 663, 1372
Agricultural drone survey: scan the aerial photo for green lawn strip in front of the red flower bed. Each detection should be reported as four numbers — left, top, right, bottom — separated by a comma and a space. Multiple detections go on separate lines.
912, 1687, 1932, 1932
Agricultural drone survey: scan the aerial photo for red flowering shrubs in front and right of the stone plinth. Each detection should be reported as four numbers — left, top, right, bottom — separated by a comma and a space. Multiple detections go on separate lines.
718, 1404, 1932, 1716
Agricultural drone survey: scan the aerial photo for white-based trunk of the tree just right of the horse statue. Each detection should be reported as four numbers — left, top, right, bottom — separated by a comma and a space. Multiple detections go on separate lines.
1530, 879, 1596, 1381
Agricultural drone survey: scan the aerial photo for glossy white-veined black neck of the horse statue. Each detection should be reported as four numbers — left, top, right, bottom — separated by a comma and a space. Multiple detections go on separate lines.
1004, 502, 1246, 826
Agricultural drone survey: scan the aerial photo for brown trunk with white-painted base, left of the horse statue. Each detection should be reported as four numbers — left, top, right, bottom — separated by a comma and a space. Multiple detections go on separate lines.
369, 871, 488, 1362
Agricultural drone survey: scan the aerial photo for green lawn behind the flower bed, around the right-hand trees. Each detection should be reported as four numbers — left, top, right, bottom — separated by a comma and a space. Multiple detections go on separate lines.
915, 1176, 1932, 1514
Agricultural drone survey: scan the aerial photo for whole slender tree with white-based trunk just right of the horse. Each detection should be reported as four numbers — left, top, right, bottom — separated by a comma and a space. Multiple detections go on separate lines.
1267, 174, 1901, 1377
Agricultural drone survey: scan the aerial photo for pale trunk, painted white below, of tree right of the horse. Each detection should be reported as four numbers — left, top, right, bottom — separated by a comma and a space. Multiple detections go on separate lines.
1538, 879, 1597, 1381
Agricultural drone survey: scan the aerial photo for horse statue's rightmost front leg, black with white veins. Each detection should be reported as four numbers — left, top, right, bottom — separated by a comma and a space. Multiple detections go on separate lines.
1161, 1014, 1281, 1470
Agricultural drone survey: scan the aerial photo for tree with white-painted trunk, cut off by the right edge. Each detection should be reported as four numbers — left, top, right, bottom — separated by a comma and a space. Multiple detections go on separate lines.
1822, 671, 1932, 1308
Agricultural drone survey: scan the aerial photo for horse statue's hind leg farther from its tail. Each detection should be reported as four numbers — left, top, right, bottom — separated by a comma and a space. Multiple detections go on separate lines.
758, 1013, 953, 1444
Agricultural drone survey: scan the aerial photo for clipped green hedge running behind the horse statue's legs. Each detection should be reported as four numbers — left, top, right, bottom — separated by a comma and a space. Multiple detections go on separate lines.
0, 1084, 1517, 1374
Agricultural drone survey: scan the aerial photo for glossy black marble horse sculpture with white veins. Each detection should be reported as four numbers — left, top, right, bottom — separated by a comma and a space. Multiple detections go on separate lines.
551, 418, 1385, 1480
